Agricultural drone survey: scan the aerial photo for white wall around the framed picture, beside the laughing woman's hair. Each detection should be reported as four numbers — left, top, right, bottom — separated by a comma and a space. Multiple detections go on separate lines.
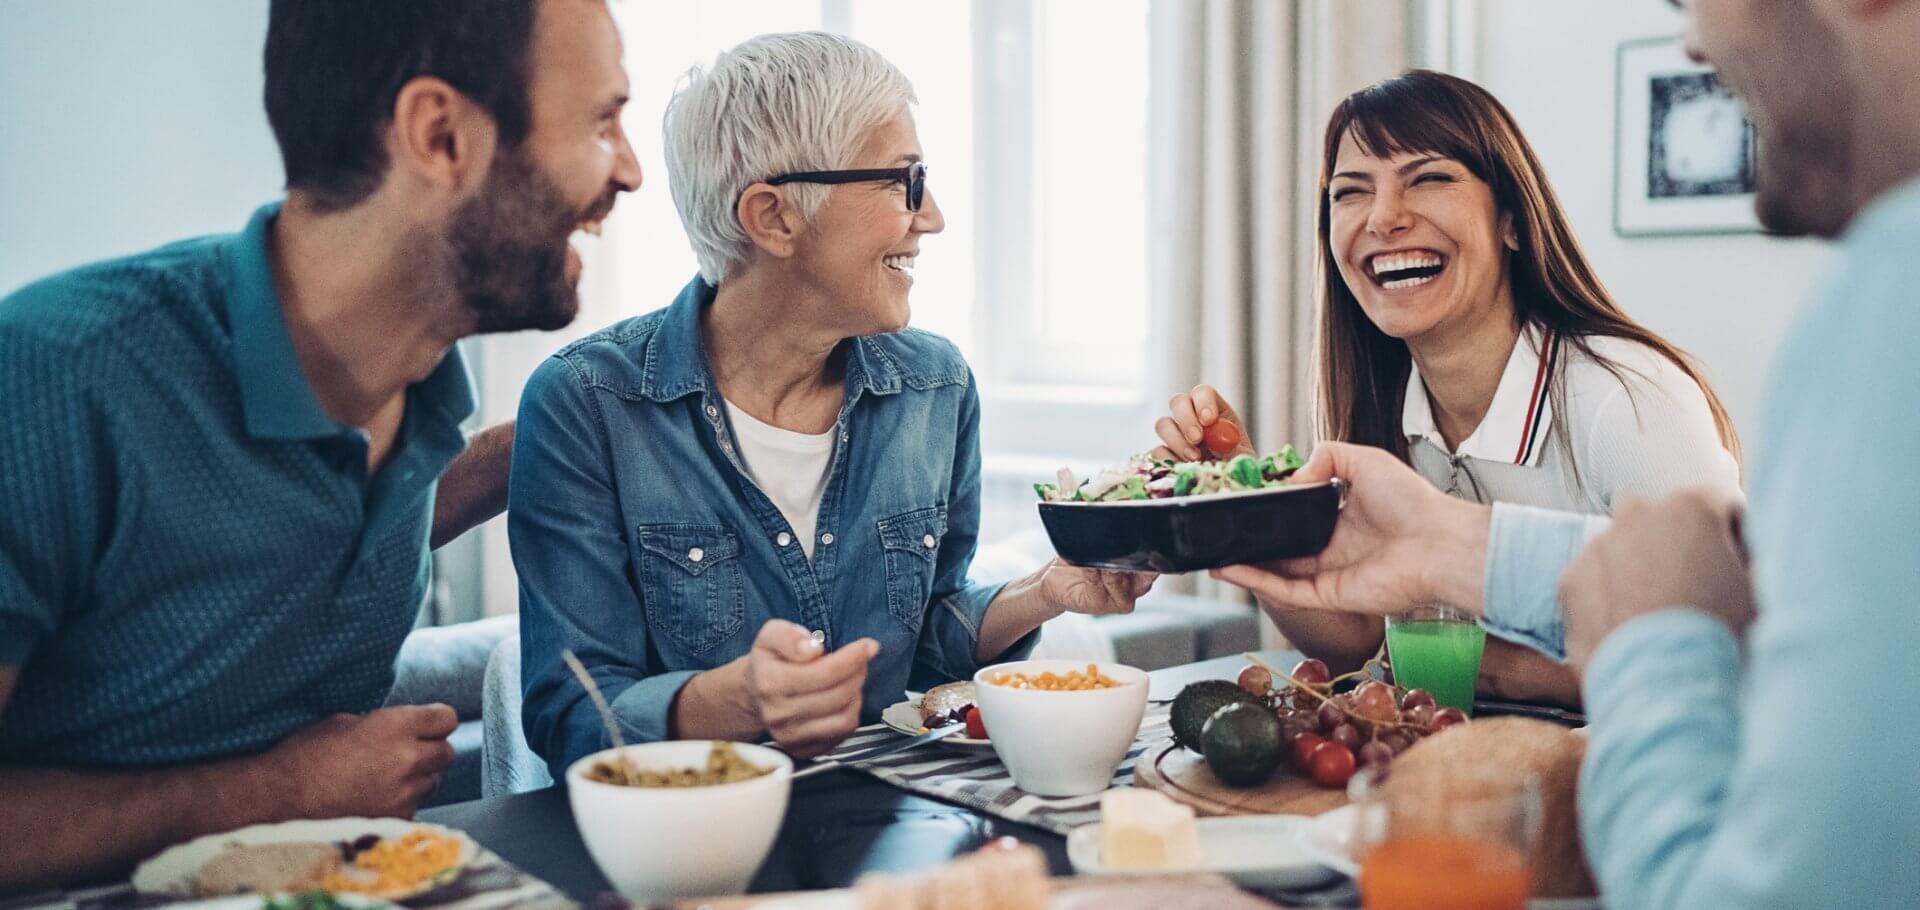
1453, 0, 1828, 442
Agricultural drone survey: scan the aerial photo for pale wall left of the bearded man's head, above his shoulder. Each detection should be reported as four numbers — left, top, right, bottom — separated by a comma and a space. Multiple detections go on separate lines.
0, 0, 280, 296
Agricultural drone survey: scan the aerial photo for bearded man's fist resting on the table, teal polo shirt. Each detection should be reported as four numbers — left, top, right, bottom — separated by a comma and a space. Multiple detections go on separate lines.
259, 705, 461, 818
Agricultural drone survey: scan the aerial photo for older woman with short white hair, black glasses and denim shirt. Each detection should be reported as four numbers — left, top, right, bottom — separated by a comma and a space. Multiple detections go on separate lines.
509, 33, 1152, 776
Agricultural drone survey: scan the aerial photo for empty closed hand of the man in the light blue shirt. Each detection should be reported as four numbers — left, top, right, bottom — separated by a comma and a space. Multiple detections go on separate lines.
1561, 490, 1753, 676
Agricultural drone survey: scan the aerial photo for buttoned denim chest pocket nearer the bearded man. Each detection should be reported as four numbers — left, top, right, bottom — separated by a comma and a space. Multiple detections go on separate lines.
634, 524, 747, 655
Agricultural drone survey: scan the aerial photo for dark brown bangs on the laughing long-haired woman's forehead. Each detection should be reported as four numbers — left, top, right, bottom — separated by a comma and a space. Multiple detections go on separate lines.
1327, 73, 1498, 182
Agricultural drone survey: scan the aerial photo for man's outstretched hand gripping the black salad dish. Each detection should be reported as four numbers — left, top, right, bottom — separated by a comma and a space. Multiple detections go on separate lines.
1213, 442, 1490, 616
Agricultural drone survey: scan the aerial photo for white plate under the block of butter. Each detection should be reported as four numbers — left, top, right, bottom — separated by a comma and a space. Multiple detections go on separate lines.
1068, 816, 1334, 889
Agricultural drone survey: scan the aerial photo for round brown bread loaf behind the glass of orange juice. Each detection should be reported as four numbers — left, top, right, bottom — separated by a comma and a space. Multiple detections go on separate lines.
1386, 718, 1596, 897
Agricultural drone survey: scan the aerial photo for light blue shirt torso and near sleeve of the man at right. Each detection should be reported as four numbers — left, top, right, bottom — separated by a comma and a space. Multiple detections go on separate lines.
1580, 194, 1920, 910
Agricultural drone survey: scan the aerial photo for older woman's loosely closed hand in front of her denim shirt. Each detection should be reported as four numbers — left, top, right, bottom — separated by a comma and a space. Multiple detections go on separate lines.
747, 620, 879, 758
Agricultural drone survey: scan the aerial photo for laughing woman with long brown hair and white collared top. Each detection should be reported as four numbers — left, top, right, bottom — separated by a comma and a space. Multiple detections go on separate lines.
1156, 71, 1740, 703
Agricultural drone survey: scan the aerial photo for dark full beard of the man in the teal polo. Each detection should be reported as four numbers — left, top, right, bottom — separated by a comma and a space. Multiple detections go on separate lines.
447, 148, 584, 334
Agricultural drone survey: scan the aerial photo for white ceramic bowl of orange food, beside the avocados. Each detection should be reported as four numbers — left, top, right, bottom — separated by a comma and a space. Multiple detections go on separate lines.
973, 660, 1146, 797
